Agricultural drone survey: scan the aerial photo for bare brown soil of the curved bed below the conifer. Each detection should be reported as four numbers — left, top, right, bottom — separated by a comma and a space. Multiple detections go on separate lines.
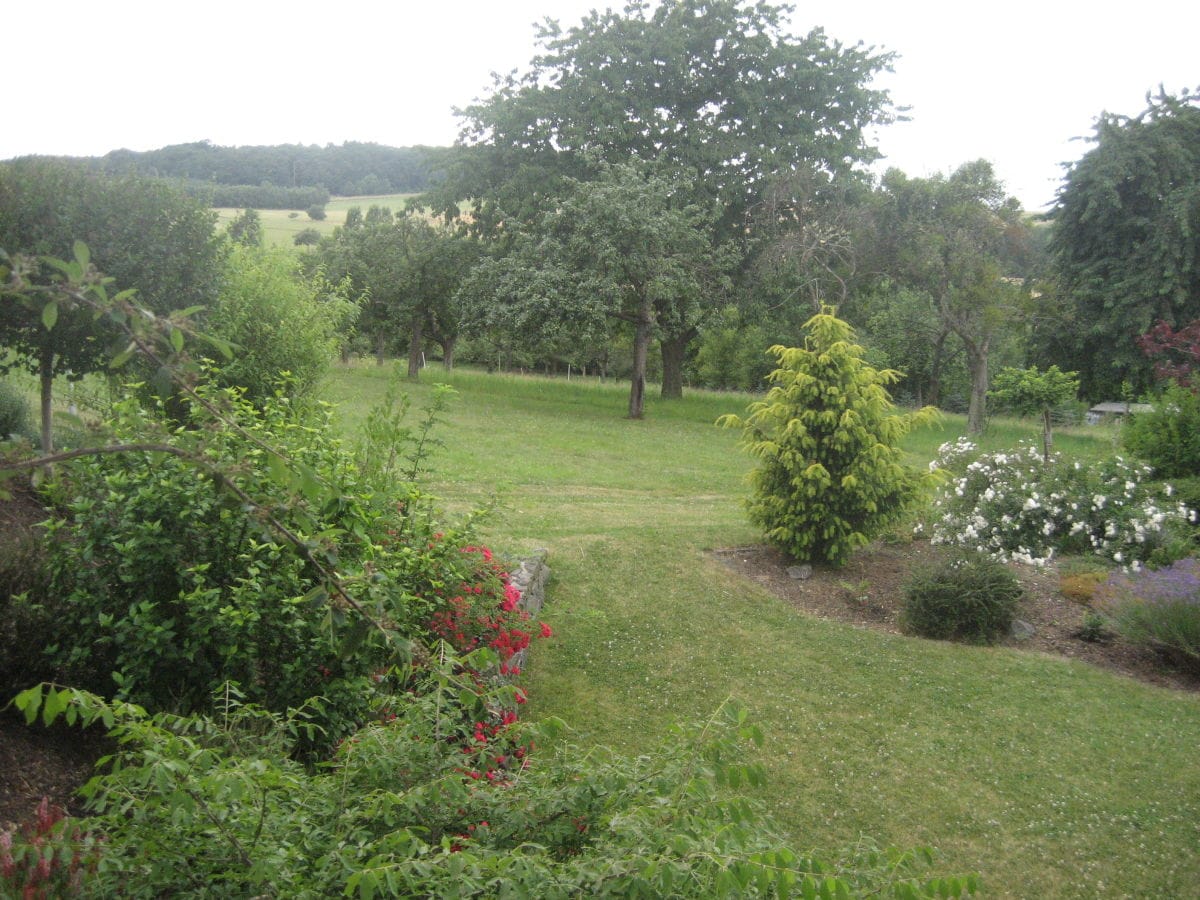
713, 540, 1200, 691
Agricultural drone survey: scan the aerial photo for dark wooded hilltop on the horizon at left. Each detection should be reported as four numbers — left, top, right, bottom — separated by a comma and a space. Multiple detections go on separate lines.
81, 140, 448, 209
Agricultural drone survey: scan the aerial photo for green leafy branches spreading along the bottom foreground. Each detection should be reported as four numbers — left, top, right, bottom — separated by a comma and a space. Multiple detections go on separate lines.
7, 681, 977, 898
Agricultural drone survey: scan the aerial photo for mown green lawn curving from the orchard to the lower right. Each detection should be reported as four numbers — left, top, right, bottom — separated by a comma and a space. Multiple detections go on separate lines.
328, 365, 1200, 898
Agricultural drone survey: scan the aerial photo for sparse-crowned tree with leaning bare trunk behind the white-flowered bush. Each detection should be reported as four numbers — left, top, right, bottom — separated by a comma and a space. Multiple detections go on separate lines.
877, 160, 1028, 434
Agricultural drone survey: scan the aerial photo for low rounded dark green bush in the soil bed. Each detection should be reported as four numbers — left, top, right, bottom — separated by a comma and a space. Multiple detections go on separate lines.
901, 554, 1021, 643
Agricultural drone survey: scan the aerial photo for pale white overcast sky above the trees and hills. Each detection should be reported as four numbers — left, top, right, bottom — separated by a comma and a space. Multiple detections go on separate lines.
0, 0, 1200, 211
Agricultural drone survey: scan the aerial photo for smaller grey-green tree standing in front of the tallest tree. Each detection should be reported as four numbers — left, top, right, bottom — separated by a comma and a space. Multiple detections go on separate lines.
461, 163, 727, 419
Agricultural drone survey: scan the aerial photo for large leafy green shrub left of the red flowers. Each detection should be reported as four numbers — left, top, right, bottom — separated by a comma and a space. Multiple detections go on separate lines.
22, 381, 468, 739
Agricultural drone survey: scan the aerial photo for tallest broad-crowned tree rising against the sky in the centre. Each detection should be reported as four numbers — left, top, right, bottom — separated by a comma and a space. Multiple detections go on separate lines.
437, 0, 890, 395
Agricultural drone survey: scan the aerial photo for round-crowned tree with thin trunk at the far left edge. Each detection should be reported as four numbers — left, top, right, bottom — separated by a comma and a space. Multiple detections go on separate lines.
0, 157, 224, 451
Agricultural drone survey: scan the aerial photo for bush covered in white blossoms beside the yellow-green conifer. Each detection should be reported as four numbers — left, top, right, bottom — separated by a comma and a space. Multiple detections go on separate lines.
929, 438, 1196, 570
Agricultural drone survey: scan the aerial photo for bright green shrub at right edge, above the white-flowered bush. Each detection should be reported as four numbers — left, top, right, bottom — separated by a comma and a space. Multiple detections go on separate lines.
1121, 382, 1200, 479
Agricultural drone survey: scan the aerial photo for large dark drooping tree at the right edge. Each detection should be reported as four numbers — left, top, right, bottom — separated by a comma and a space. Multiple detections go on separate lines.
1040, 91, 1200, 397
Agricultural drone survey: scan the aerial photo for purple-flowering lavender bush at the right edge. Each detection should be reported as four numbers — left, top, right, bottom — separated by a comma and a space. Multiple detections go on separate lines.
1094, 558, 1200, 672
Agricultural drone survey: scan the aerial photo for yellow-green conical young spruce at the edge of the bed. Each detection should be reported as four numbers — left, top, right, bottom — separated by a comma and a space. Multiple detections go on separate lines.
718, 307, 938, 565
